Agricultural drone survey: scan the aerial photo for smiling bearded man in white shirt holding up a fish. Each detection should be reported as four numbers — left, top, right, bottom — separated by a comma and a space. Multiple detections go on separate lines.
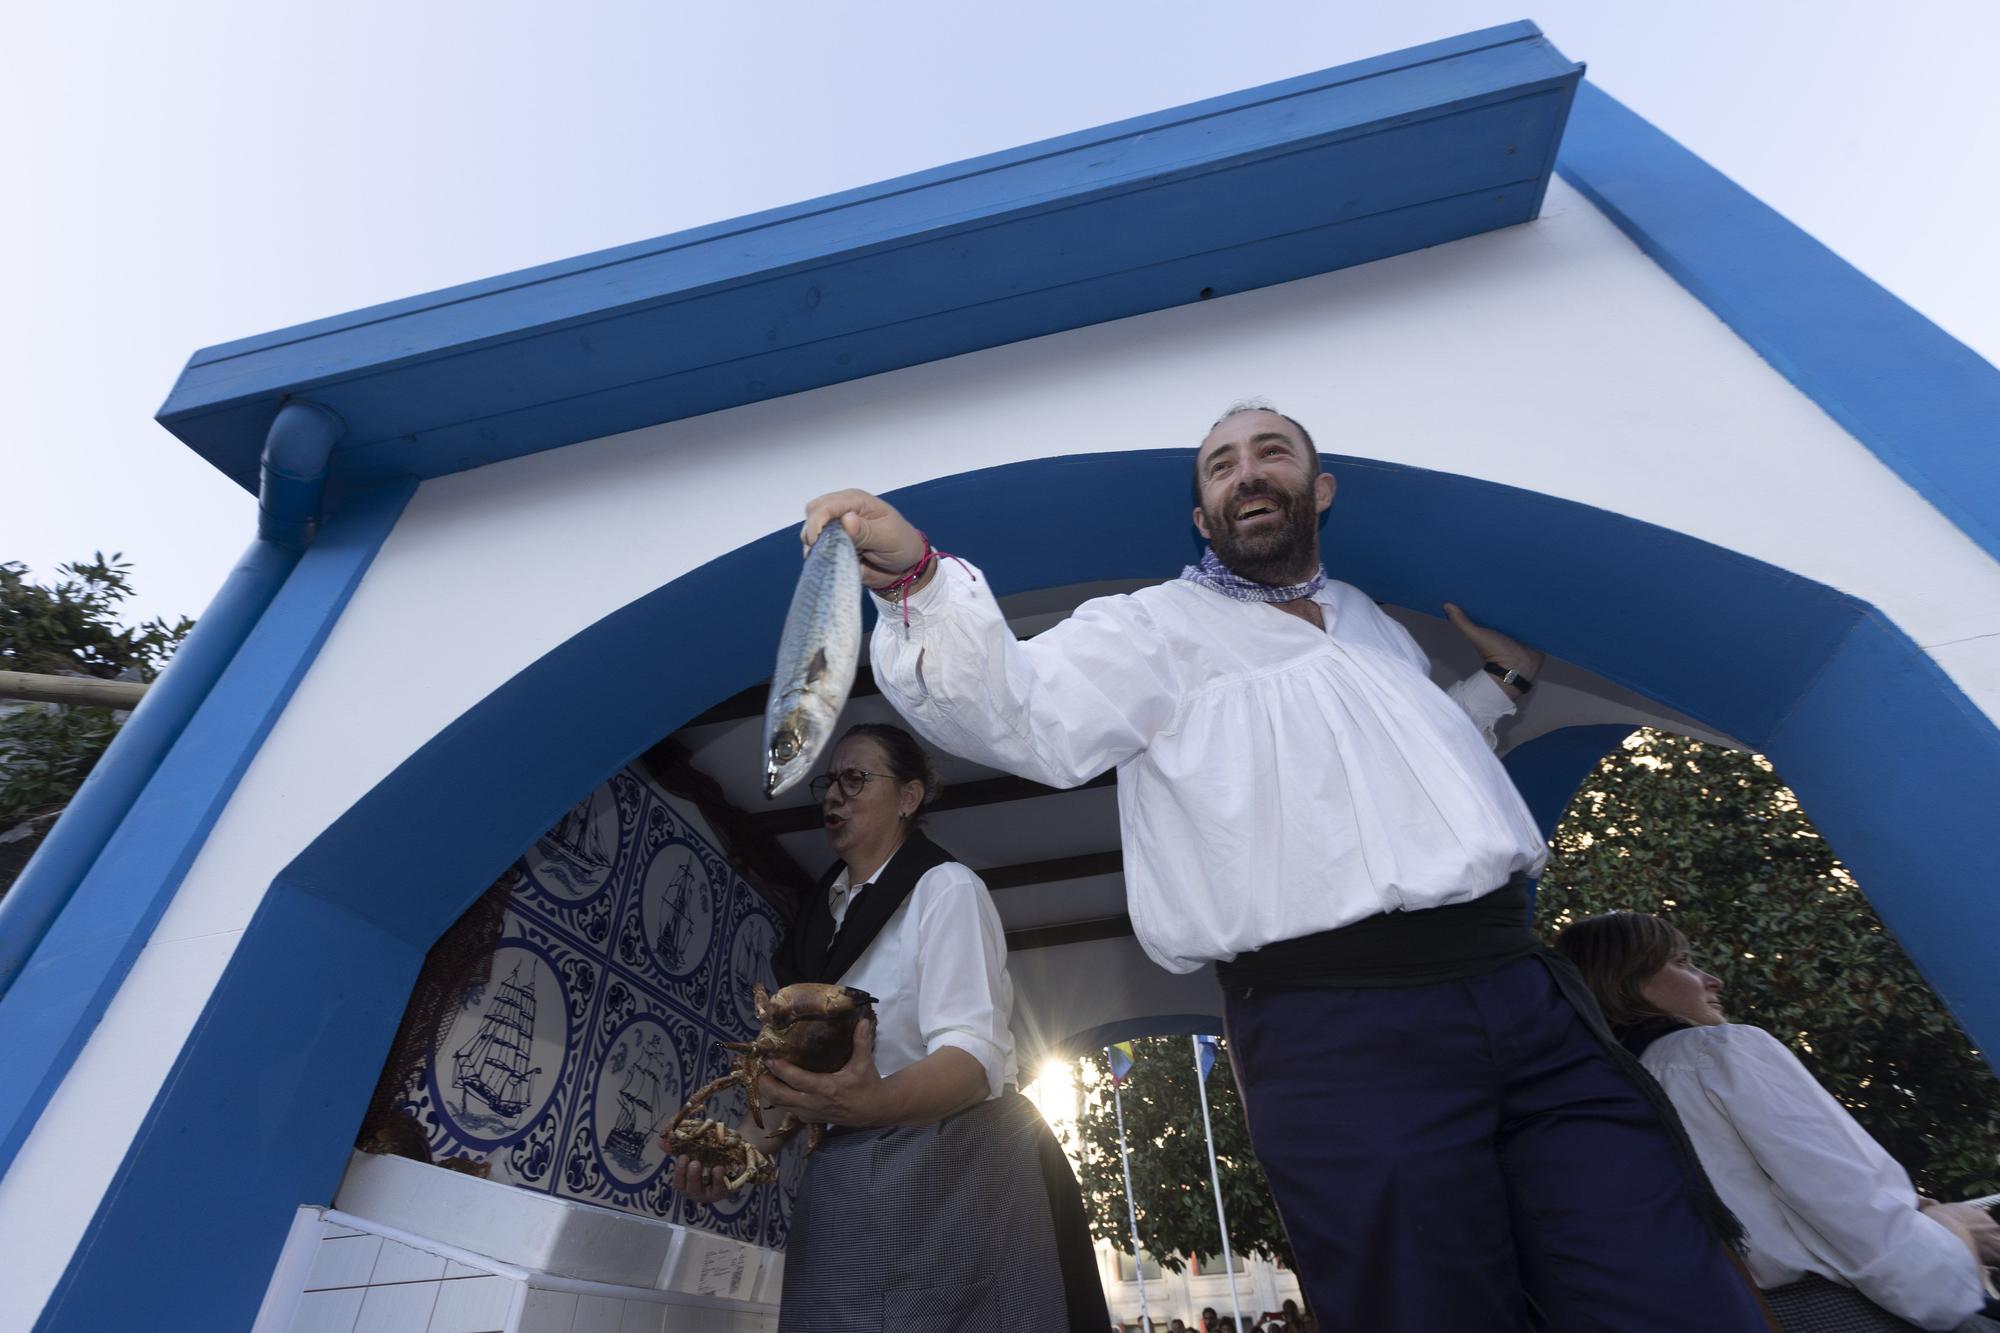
802, 404, 1766, 1333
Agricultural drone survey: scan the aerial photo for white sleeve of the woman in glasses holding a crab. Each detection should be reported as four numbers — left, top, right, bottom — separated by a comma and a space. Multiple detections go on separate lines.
910, 861, 1014, 1097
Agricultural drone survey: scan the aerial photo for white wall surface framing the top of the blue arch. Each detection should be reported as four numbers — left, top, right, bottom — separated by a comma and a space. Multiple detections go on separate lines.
0, 182, 2000, 1325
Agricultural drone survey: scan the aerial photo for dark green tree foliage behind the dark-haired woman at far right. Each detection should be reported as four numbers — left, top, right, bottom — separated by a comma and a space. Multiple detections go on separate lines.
1536, 731, 2000, 1199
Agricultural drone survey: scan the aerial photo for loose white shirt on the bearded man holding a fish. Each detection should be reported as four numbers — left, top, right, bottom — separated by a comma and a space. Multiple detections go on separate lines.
870, 560, 1548, 973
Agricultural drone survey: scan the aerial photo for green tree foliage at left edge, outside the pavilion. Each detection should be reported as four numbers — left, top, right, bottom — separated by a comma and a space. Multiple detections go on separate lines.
0, 552, 194, 893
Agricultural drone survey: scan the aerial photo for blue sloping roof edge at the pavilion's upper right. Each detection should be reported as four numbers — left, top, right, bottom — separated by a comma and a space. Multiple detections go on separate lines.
1556, 84, 2000, 560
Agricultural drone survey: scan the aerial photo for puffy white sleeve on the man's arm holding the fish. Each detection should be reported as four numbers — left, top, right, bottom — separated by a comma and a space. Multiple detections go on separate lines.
870, 560, 1180, 787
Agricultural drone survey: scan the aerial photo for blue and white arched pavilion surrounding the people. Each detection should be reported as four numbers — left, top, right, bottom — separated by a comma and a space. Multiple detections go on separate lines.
0, 24, 2000, 1333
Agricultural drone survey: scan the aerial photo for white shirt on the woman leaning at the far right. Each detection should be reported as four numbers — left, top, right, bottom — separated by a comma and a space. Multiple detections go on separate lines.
1640, 1023, 1986, 1329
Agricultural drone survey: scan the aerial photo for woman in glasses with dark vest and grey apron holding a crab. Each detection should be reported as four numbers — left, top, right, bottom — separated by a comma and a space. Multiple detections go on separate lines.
672, 723, 1110, 1333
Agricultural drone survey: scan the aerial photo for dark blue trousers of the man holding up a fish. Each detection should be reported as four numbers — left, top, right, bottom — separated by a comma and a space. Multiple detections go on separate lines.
1226, 957, 1768, 1333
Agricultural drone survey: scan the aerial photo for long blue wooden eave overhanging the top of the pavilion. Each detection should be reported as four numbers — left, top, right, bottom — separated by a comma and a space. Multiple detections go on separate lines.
160, 22, 1582, 484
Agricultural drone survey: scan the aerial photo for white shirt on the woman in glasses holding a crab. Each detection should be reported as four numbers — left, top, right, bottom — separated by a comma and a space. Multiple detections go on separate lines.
828, 855, 1016, 1099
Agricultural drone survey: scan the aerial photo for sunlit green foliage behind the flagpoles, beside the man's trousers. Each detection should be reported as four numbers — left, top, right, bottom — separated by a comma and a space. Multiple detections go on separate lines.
1070, 1037, 1292, 1273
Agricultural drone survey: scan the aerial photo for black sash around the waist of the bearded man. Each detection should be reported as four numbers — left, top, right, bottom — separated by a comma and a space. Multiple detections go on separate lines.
1216, 875, 1542, 991
